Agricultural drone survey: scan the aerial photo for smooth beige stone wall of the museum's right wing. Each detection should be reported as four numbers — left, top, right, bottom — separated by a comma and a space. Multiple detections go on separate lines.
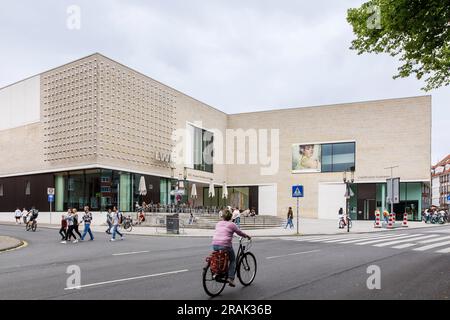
228, 96, 431, 217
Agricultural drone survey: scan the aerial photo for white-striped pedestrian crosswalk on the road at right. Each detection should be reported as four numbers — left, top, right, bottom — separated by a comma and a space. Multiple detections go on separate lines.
280, 232, 450, 254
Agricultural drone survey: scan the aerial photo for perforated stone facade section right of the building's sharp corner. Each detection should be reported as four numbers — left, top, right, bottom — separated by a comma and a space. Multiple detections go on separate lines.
98, 57, 177, 168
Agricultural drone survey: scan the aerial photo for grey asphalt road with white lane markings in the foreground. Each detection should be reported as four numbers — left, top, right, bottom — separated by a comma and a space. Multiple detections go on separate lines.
0, 225, 450, 300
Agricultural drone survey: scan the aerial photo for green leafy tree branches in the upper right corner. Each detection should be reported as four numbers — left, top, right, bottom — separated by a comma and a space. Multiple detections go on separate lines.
347, 0, 450, 91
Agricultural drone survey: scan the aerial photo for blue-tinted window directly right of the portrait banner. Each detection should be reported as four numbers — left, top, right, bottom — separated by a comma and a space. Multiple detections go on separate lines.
322, 142, 355, 172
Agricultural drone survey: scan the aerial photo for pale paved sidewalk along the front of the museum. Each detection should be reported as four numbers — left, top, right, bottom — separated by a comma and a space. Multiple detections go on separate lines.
0, 218, 447, 237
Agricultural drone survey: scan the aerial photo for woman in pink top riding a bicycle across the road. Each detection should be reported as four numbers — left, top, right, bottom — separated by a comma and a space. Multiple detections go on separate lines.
212, 210, 251, 287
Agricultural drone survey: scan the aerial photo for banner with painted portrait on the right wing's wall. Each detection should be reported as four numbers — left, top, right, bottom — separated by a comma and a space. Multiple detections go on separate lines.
292, 144, 322, 173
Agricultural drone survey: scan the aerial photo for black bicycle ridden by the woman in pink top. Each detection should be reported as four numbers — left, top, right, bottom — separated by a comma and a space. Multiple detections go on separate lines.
202, 238, 257, 297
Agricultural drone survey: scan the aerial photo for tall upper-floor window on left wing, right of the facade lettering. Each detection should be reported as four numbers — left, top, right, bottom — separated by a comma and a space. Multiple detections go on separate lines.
189, 125, 214, 173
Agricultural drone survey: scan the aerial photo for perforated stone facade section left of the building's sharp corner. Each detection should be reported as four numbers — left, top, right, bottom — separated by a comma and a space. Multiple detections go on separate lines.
41, 56, 98, 162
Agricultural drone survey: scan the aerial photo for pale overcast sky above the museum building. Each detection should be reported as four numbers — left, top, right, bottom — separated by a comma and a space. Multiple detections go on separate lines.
0, 0, 450, 162
